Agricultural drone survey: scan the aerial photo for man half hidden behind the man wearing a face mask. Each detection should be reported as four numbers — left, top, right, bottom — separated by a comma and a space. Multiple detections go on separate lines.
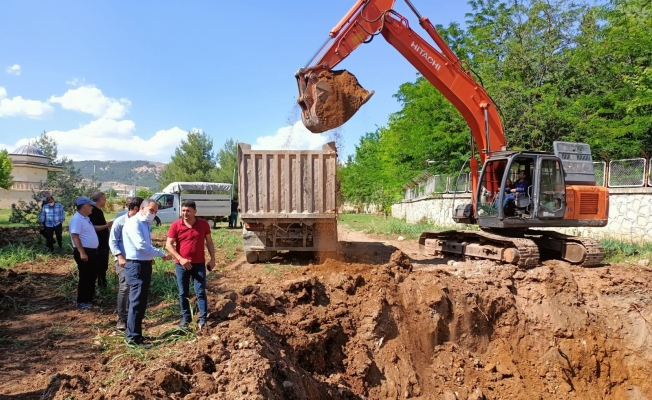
109, 197, 143, 331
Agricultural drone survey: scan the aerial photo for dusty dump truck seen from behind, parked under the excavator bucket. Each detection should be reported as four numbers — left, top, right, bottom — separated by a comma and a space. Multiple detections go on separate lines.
238, 142, 339, 263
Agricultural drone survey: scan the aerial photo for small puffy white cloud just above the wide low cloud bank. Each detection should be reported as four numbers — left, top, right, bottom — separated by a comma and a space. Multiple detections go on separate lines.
50, 85, 131, 119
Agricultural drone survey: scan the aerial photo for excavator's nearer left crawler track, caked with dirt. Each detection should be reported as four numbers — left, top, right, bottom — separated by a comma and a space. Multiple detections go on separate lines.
419, 231, 539, 268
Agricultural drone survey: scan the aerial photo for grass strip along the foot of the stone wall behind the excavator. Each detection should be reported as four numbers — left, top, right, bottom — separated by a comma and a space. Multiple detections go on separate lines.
339, 214, 652, 263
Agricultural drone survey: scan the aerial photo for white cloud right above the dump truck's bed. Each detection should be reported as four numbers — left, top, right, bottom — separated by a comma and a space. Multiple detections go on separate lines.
251, 121, 327, 150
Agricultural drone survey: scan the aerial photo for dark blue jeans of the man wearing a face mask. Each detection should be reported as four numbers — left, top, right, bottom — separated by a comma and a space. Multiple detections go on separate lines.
125, 260, 152, 341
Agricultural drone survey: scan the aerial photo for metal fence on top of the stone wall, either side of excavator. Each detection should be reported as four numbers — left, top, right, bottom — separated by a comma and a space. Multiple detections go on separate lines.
403, 158, 652, 200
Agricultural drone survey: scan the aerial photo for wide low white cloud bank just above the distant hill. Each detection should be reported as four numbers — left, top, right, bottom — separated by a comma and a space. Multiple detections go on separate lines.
16, 118, 188, 162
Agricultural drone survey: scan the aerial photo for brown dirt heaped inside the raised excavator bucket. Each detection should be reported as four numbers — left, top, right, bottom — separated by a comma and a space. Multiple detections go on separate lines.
308, 70, 370, 131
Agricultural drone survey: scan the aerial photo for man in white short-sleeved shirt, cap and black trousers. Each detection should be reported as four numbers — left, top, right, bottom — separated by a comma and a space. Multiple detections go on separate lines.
68, 196, 100, 310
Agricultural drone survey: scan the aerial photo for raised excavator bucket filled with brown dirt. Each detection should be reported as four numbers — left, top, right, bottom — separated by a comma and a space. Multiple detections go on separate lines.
297, 70, 374, 133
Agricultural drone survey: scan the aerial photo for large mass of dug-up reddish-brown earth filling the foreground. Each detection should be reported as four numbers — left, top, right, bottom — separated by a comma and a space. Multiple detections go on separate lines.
48, 251, 652, 400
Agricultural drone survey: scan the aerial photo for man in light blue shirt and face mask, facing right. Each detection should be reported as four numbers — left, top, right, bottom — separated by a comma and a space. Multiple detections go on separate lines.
122, 199, 170, 349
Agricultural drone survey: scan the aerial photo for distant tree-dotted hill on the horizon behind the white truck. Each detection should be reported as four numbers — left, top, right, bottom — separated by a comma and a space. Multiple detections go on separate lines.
73, 160, 166, 191
